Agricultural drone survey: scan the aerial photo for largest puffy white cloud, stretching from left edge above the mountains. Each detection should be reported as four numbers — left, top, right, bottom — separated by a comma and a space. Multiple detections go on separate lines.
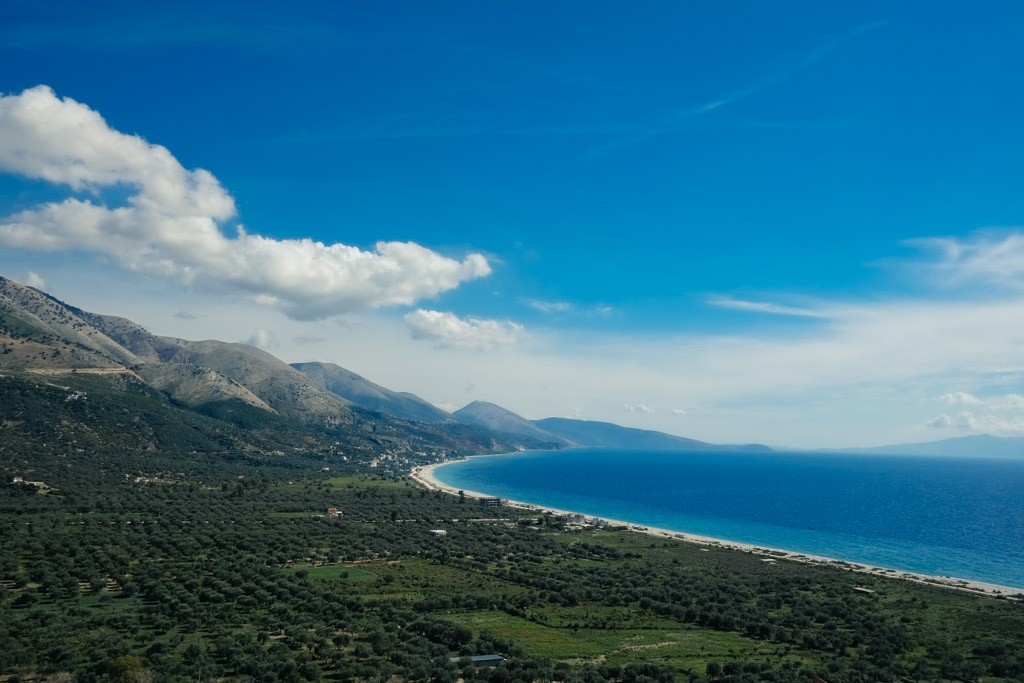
0, 86, 490, 319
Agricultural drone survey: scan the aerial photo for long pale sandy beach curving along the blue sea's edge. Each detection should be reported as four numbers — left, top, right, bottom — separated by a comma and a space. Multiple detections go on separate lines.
410, 454, 1024, 599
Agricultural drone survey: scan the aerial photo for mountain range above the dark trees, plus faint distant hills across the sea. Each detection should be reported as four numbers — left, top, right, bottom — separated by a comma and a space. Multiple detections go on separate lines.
0, 276, 1024, 456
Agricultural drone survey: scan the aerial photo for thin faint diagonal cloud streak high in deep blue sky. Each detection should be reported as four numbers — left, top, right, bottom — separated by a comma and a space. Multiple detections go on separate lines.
590, 22, 888, 155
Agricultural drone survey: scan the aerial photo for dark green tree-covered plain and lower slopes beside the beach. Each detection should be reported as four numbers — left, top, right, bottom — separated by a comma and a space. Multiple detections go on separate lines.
0, 377, 1024, 683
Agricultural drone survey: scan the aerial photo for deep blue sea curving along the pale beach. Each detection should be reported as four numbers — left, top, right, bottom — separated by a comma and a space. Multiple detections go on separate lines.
435, 449, 1024, 589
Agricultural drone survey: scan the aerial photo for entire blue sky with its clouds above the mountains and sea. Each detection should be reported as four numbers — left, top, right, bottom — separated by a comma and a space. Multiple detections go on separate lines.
0, 0, 1024, 446
